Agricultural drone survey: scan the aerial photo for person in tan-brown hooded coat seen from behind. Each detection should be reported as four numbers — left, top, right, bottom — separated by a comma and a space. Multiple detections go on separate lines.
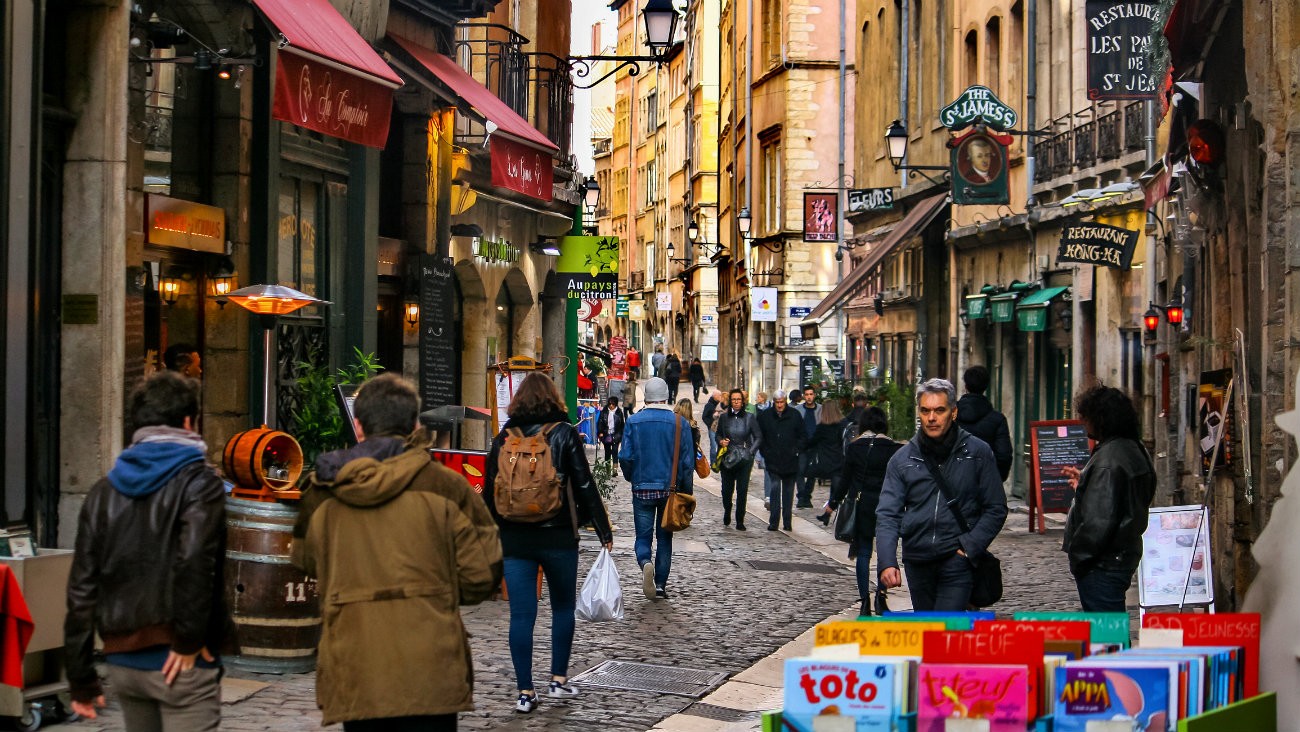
291, 373, 502, 732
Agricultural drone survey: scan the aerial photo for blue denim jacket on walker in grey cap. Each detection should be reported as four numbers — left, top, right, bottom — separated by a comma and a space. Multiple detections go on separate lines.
619, 404, 696, 498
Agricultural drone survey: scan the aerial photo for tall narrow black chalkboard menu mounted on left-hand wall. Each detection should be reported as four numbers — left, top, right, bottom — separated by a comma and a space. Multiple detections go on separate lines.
420, 255, 460, 410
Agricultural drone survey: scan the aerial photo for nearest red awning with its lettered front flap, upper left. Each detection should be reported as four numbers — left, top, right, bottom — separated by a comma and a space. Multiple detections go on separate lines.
254, 0, 402, 148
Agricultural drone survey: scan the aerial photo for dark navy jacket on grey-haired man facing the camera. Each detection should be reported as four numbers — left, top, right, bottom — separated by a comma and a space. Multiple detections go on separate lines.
876, 425, 1006, 569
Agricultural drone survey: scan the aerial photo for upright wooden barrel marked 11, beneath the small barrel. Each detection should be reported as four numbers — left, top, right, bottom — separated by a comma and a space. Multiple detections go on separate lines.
225, 498, 321, 673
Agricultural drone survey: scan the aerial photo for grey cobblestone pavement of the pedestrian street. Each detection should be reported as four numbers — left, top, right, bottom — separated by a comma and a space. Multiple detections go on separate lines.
47, 397, 1078, 732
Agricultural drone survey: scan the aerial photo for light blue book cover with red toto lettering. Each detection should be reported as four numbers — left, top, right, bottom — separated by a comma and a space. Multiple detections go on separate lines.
781, 658, 898, 732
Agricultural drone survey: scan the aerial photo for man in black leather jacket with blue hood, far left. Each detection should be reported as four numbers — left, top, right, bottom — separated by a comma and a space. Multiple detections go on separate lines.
64, 371, 237, 732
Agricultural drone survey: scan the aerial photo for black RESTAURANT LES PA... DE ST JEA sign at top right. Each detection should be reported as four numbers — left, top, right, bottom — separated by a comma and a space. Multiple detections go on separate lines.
1084, 0, 1164, 101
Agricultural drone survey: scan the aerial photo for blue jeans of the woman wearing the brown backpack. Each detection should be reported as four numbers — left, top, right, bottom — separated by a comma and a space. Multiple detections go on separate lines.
504, 546, 577, 690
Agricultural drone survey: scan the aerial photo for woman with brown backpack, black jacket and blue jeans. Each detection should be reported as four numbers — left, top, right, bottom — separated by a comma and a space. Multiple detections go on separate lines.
484, 372, 614, 714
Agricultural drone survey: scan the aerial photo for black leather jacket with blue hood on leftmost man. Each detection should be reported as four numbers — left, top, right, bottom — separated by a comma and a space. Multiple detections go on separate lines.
64, 426, 235, 702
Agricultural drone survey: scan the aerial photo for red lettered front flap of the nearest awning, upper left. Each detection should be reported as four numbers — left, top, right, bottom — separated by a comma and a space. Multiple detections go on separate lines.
272, 48, 393, 150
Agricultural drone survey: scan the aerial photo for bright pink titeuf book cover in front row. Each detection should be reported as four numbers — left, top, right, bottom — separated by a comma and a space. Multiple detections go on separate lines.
917, 663, 1031, 732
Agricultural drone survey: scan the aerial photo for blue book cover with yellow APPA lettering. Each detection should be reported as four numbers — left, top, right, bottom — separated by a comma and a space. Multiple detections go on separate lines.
1053, 664, 1170, 732
